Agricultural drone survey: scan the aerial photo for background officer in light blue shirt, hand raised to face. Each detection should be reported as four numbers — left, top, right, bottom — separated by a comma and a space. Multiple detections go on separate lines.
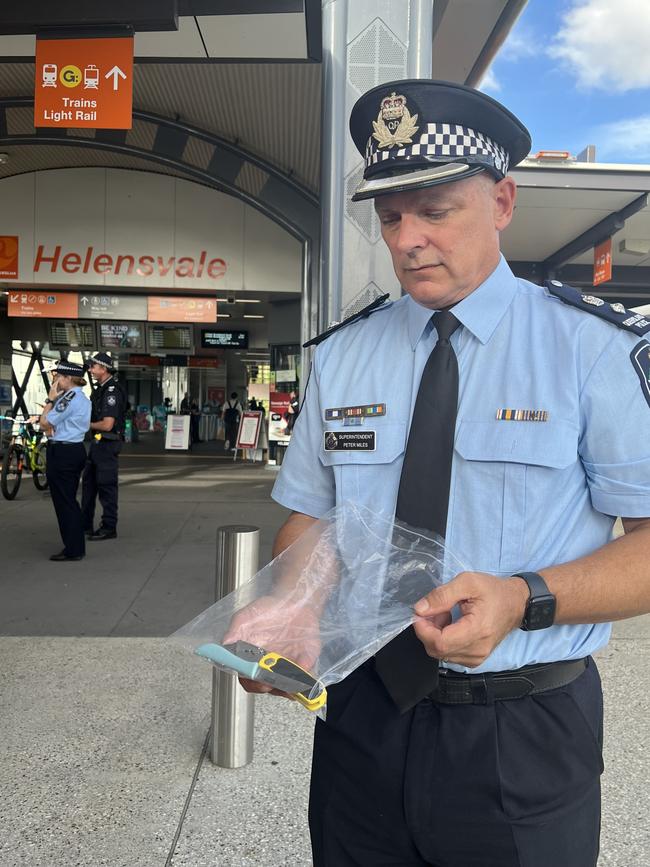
40, 361, 90, 562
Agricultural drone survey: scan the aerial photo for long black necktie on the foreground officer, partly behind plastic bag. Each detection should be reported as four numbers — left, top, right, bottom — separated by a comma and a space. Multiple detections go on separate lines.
375, 310, 460, 713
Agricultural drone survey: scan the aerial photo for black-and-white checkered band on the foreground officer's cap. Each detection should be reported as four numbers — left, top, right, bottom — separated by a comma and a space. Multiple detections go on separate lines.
366, 123, 509, 176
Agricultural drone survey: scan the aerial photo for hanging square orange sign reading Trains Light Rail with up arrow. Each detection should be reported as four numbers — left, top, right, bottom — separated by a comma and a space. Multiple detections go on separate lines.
34, 37, 133, 129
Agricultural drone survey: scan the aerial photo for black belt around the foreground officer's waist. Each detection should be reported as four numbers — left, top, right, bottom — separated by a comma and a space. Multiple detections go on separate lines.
428, 658, 587, 704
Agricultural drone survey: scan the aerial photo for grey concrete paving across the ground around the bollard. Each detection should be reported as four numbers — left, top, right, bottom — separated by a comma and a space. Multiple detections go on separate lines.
0, 446, 650, 867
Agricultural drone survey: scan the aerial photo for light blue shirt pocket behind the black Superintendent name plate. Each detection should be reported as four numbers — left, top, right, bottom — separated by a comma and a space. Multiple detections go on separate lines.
319, 418, 406, 502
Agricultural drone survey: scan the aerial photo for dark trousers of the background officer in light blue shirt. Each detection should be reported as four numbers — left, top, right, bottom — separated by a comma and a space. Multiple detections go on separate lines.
46, 442, 86, 557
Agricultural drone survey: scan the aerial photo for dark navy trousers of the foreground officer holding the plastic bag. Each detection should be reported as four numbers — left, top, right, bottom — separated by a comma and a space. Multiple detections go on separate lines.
309, 660, 603, 867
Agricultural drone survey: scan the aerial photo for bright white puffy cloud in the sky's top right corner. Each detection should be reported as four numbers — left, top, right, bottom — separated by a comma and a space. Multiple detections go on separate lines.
548, 0, 650, 91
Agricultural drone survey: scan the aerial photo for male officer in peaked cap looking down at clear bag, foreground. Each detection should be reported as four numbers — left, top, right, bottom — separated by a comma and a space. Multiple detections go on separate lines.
235, 80, 650, 867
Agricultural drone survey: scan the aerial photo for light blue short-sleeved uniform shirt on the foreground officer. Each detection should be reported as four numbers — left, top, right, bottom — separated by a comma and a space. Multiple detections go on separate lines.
272, 258, 650, 672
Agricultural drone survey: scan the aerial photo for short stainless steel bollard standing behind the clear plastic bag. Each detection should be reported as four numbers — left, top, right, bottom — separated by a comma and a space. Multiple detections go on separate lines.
210, 524, 260, 768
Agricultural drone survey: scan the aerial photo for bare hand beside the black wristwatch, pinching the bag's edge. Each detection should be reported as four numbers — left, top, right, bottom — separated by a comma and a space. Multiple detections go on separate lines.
413, 572, 529, 668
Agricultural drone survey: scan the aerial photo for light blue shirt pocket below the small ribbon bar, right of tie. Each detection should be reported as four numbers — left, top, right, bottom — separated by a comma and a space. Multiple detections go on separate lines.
454, 420, 578, 572
